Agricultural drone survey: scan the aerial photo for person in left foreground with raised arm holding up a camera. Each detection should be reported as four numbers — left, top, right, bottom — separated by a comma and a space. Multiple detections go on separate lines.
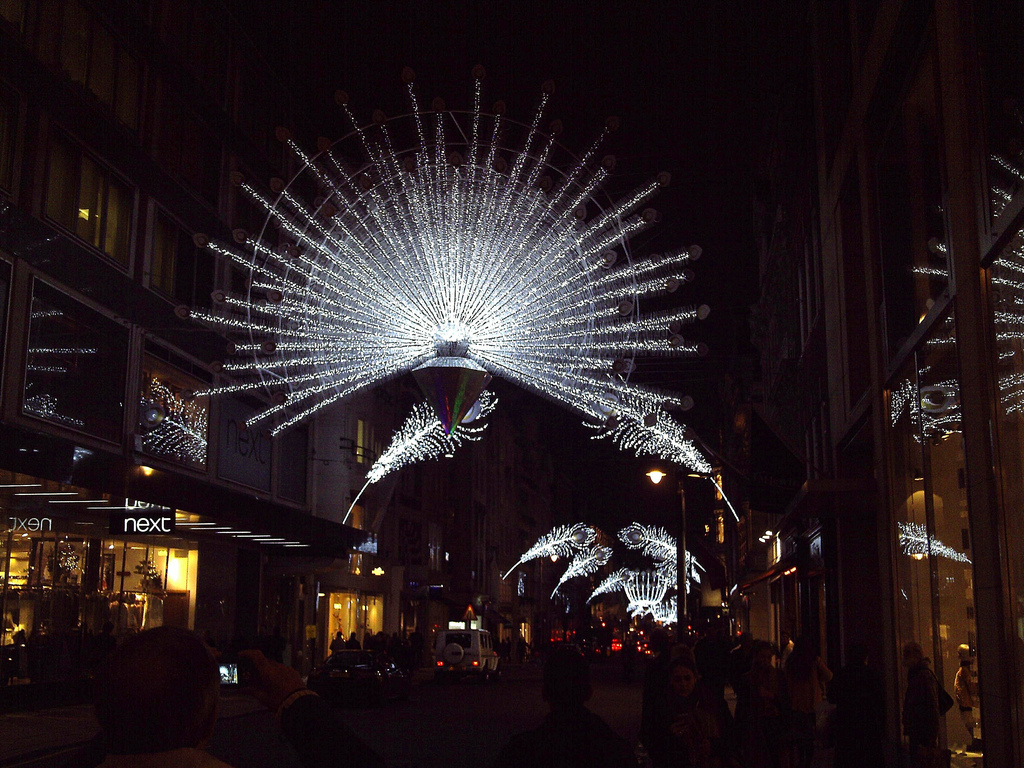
68, 627, 384, 768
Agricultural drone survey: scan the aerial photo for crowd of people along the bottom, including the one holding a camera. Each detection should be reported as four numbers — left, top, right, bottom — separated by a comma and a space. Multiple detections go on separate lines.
59, 628, 962, 768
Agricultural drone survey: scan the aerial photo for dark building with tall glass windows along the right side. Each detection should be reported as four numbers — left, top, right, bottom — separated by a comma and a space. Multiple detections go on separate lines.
755, 0, 1024, 766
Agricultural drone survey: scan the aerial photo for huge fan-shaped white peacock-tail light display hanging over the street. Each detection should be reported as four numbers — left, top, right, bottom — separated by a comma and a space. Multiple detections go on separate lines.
178, 68, 709, 469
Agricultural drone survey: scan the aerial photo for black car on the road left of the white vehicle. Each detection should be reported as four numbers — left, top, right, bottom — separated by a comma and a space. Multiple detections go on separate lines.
306, 649, 412, 705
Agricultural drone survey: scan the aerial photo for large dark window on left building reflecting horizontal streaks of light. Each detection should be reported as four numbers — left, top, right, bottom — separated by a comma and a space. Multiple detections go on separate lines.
22, 280, 128, 442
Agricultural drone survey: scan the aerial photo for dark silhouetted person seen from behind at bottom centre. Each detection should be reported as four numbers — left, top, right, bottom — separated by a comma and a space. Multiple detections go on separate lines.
493, 647, 637, 768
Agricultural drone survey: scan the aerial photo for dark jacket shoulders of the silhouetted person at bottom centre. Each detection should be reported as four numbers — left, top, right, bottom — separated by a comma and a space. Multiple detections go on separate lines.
493, 707, 637, 768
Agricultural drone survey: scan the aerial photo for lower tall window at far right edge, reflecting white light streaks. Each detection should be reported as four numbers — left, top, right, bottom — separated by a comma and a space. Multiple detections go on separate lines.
988, 229, 1024, 753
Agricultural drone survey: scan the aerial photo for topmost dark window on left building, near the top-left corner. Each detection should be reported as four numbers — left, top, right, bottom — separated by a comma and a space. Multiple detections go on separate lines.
60, 2, 141, 130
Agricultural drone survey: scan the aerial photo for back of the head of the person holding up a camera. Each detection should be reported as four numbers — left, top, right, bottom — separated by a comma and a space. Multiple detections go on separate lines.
95, 627, 220, 755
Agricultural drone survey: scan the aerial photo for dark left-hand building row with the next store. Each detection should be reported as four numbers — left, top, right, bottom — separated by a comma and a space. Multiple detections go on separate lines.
0, 0, 565, 700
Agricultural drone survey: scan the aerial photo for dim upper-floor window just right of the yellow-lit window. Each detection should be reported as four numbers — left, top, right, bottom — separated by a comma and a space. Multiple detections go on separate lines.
150, 209, 215, 307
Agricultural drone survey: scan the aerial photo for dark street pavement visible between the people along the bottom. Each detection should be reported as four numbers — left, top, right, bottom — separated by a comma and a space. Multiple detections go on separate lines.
0, 662, 983, 768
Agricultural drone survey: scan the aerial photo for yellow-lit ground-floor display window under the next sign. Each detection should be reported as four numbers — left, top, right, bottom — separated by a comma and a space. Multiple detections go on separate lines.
0, 508, 199, 683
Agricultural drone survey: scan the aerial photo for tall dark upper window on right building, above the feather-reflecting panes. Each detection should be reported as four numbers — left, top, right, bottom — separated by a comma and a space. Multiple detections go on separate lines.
878, 43, 950, 359
